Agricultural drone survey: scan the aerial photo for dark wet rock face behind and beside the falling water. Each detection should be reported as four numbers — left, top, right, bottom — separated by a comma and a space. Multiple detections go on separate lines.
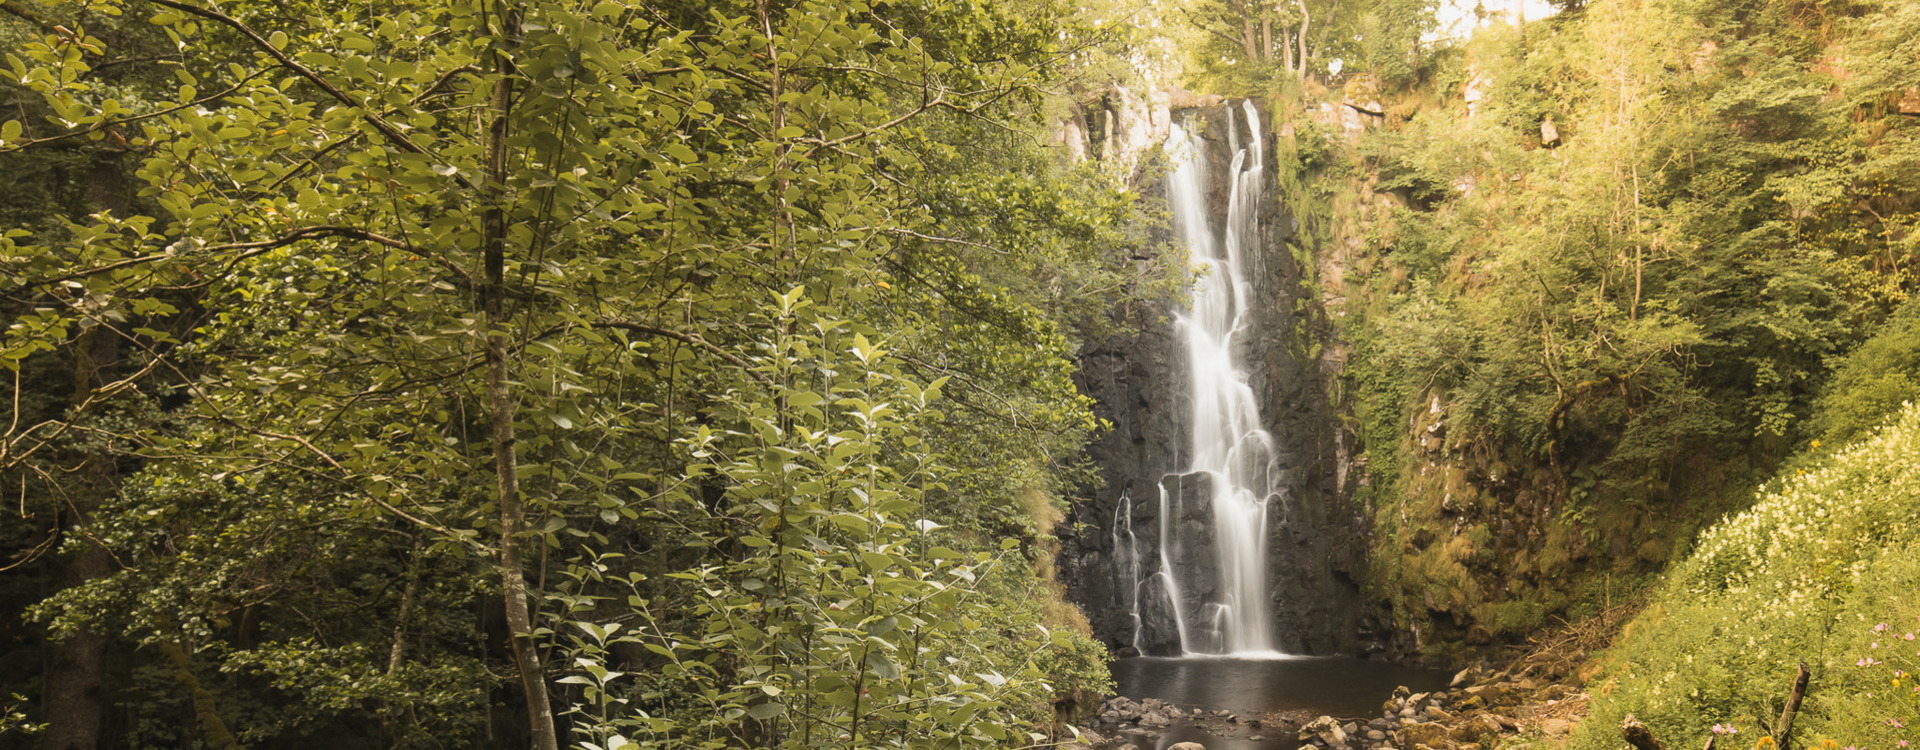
1060, 102, 1367, 654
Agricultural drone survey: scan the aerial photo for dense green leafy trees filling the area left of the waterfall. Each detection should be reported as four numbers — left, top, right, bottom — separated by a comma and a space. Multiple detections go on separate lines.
0, 0, 1136, 746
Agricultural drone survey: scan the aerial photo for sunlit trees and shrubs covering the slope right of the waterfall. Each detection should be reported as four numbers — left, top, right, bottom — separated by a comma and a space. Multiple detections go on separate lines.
1332, 0, 1920, 643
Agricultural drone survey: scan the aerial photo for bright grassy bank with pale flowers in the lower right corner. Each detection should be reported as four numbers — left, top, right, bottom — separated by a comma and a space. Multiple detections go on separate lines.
1574, 407, 1920, 748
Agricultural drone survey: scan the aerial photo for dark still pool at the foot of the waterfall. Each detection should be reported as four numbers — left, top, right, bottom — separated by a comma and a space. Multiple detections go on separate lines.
1114, 656, 1452, 750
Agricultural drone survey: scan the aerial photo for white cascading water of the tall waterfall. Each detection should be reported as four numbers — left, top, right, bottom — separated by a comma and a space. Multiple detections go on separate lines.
1116, 102, 1281, 656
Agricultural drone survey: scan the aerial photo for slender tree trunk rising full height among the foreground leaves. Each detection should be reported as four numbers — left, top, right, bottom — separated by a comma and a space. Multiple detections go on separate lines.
480, 4, 561, 750
